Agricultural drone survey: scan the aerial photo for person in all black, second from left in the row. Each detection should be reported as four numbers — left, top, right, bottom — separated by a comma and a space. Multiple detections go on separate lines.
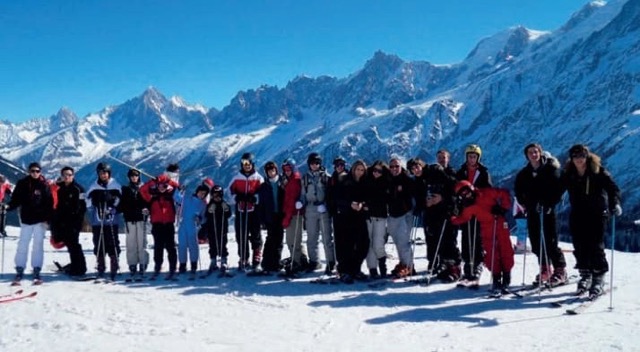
51, 166, 87, 276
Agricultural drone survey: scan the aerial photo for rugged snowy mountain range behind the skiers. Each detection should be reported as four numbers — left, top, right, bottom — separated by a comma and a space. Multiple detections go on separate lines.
0, 0, 640, 228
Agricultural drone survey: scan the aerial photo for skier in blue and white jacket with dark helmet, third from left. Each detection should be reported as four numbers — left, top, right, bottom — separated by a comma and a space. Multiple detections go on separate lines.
86, 162, 122, 281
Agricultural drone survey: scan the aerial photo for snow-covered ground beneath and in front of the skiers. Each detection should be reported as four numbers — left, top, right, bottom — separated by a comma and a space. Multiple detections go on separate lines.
0, 227, 640, 352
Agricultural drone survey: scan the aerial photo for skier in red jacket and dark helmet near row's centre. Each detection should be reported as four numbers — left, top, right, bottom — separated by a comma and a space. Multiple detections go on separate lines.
280, 158, 309, 276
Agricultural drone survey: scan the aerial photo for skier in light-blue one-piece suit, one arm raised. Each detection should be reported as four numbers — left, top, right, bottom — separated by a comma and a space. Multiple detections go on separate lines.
174, 185, 209, 279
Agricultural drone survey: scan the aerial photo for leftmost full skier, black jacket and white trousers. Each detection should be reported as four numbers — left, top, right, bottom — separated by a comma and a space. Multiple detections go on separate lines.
2, 162, 53, 285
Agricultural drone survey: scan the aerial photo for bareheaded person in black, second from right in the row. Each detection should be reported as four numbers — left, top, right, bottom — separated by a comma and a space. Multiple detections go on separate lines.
515, 143, 567, 286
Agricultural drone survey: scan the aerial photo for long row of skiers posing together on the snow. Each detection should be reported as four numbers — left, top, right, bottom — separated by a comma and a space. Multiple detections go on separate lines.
3, 143, 622, 295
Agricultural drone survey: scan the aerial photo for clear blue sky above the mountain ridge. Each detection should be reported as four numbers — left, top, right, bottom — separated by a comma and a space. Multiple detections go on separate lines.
0, 0, 587, 122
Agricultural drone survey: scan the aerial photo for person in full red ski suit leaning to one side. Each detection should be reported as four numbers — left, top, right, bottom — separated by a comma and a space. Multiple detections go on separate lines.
451, 180, 514, 290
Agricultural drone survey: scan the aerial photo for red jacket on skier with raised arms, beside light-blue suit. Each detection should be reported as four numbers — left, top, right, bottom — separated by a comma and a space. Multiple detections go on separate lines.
140, 175, 178, 224
